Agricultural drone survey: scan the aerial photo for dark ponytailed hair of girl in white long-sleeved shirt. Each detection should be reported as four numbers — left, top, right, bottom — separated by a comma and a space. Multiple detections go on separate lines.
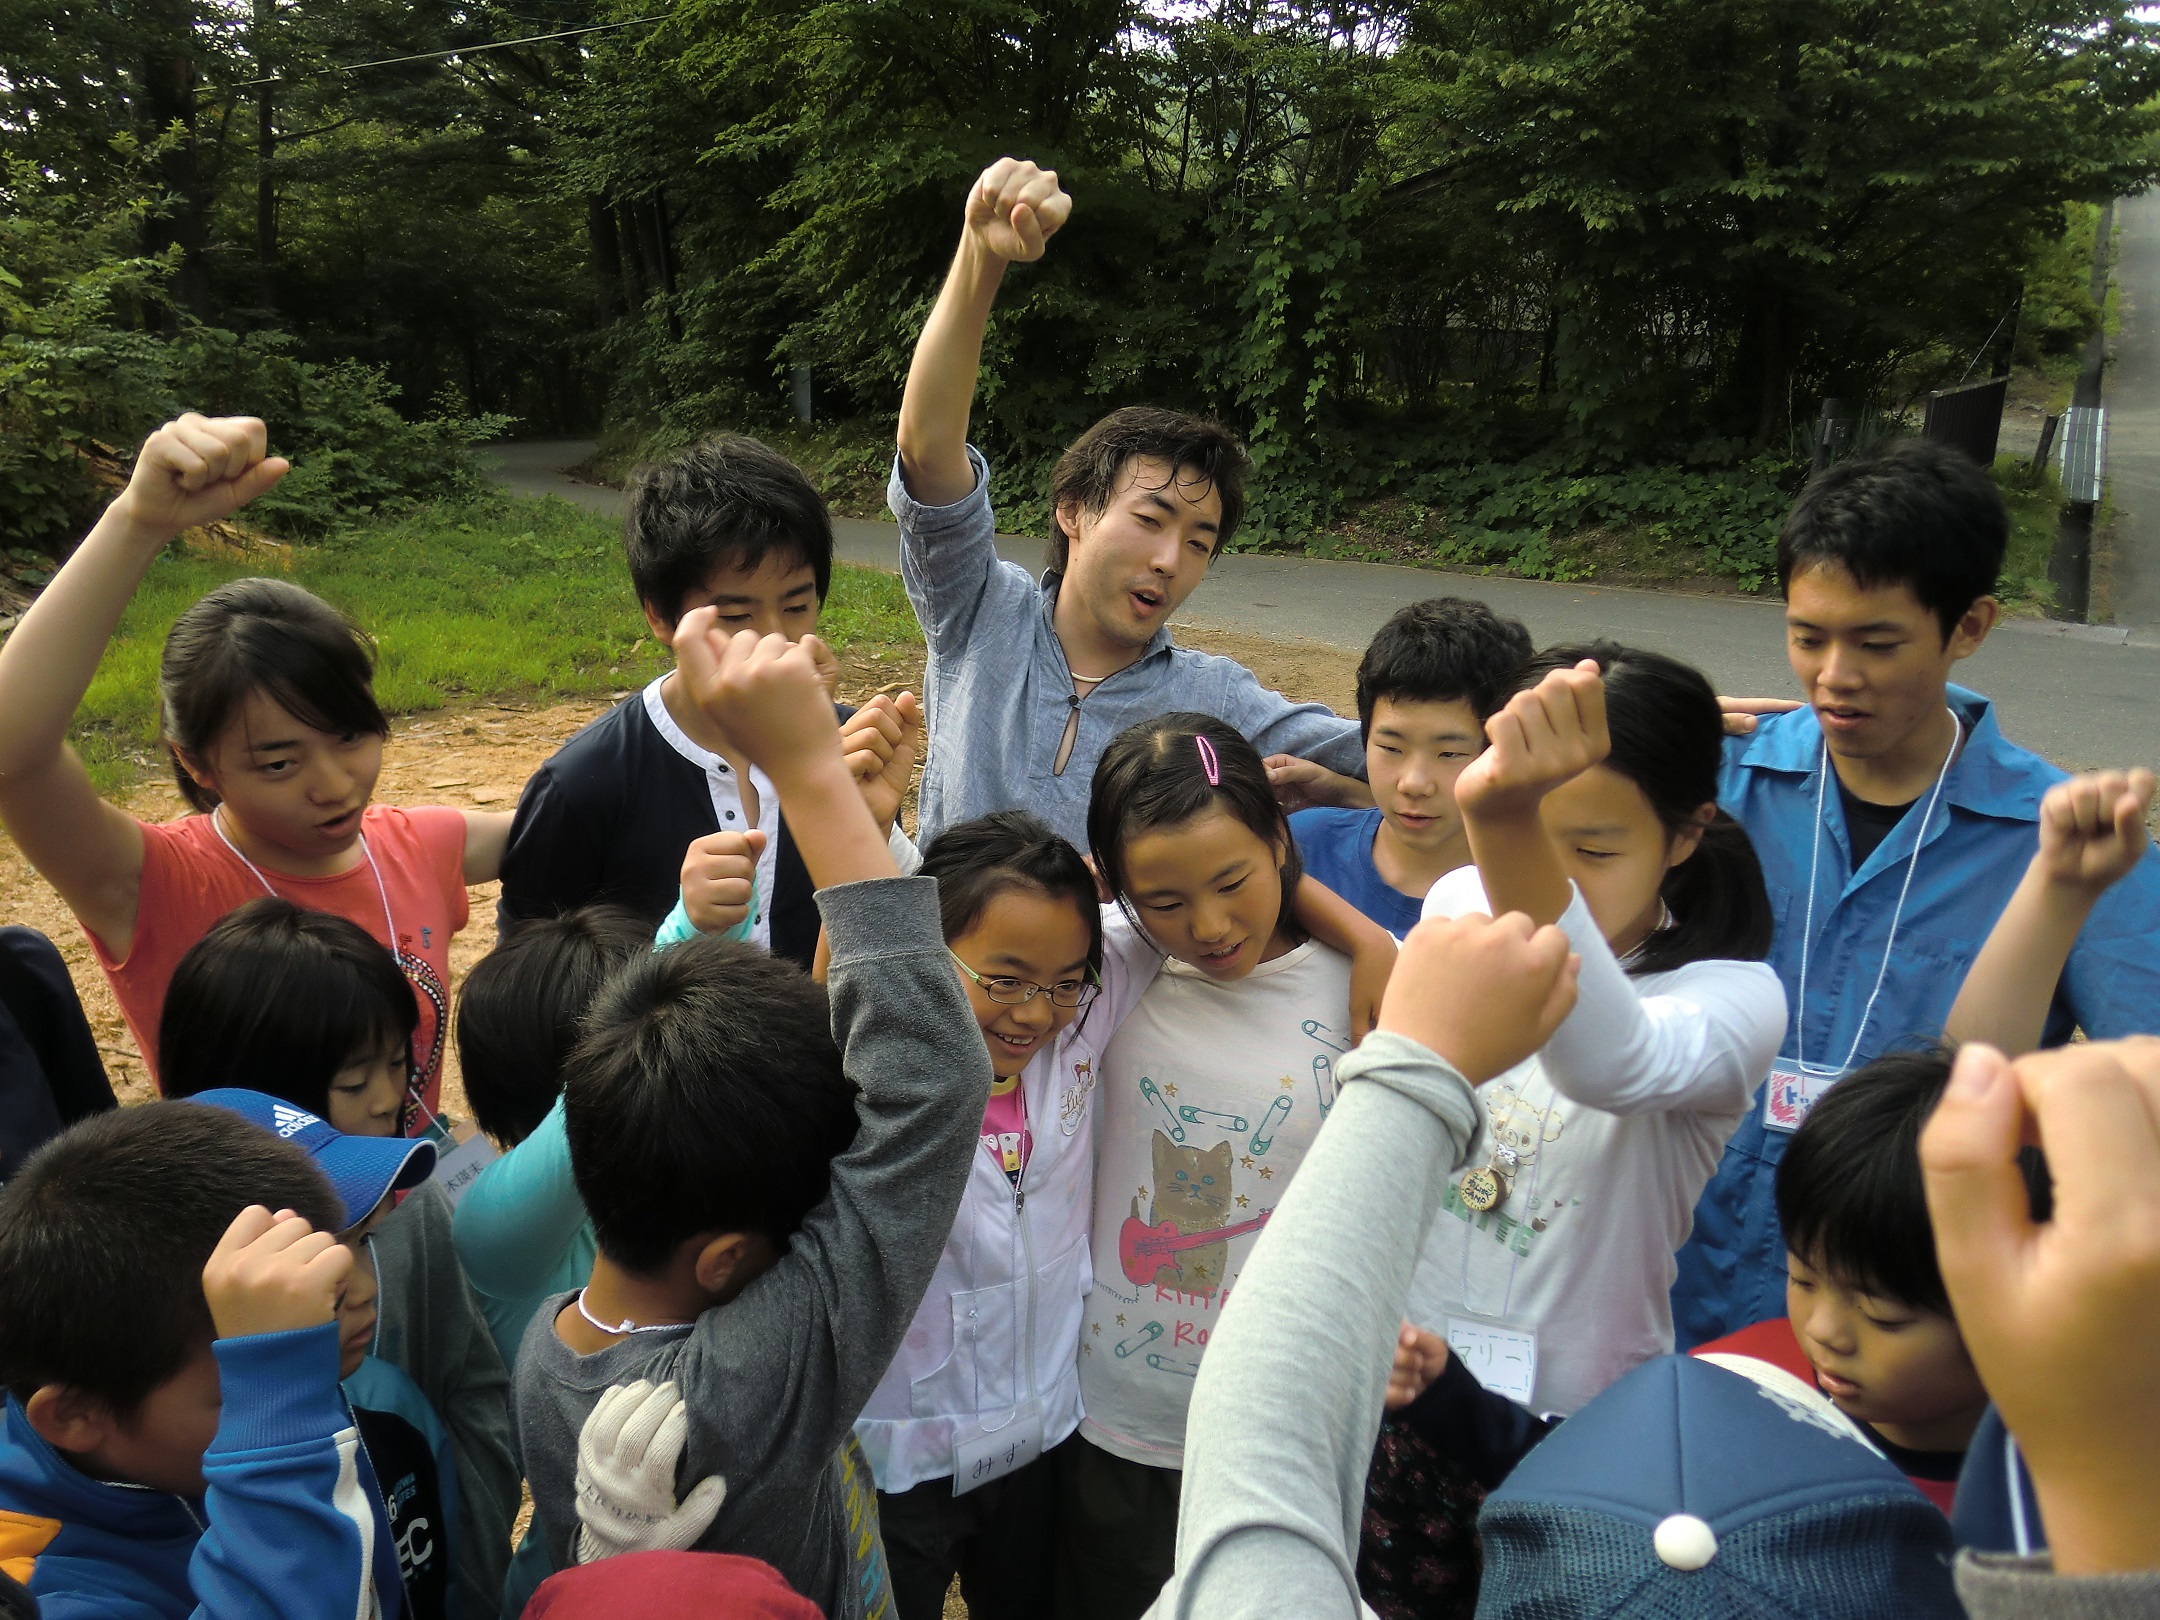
1516, 642, 1776, 974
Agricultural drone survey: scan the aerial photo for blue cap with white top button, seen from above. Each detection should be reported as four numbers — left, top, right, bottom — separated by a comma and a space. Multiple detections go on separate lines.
1477, 1356, 1963, 1620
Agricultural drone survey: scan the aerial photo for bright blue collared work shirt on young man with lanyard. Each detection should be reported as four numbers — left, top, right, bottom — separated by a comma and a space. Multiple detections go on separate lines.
1672, 687, 2160, 1348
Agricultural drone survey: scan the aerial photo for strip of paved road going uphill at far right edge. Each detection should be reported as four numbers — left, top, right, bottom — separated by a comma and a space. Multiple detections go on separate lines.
2106, 190, 2160, 626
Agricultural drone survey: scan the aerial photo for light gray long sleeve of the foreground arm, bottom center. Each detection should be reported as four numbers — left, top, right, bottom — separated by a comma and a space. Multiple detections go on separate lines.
1147, 1032, 1477, 1620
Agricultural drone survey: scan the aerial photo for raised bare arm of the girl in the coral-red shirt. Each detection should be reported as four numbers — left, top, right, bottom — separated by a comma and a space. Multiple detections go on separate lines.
0, 415, 285, 957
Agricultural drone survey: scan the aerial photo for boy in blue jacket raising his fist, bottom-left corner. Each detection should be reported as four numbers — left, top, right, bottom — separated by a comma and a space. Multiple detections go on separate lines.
0, 1102, 402, 1620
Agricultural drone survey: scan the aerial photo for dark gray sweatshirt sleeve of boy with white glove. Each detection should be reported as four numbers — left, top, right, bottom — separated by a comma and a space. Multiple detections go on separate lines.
678, 877, 989, 1475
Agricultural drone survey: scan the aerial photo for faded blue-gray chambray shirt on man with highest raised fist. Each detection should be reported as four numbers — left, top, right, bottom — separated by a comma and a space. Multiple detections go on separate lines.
886, 445, 1365, 849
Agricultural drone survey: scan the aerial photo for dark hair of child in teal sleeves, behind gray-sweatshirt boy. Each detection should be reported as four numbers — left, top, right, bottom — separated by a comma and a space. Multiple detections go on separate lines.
458, 905, 652, 1147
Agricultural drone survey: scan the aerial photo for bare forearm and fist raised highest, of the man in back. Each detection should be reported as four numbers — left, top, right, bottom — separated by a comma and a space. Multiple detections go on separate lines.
899, 158, 1071, 505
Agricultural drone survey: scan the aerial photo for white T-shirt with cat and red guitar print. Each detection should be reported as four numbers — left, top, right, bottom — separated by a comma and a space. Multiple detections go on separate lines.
1080, 924, 1350, 1469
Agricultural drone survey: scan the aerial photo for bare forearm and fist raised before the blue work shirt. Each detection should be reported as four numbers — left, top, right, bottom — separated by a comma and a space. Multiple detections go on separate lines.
1942, 771, 2154, 1056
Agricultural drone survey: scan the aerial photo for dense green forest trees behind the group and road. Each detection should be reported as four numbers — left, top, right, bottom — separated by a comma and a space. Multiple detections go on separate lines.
0, 0, 2160, 588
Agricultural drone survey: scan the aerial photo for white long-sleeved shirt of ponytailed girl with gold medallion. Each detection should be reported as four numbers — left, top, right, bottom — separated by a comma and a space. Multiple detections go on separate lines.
1408, 866, 1784, 1413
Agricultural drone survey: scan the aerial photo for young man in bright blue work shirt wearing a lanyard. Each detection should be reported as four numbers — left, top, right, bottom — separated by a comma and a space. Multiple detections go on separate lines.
1672, 441, 2160, 1348
